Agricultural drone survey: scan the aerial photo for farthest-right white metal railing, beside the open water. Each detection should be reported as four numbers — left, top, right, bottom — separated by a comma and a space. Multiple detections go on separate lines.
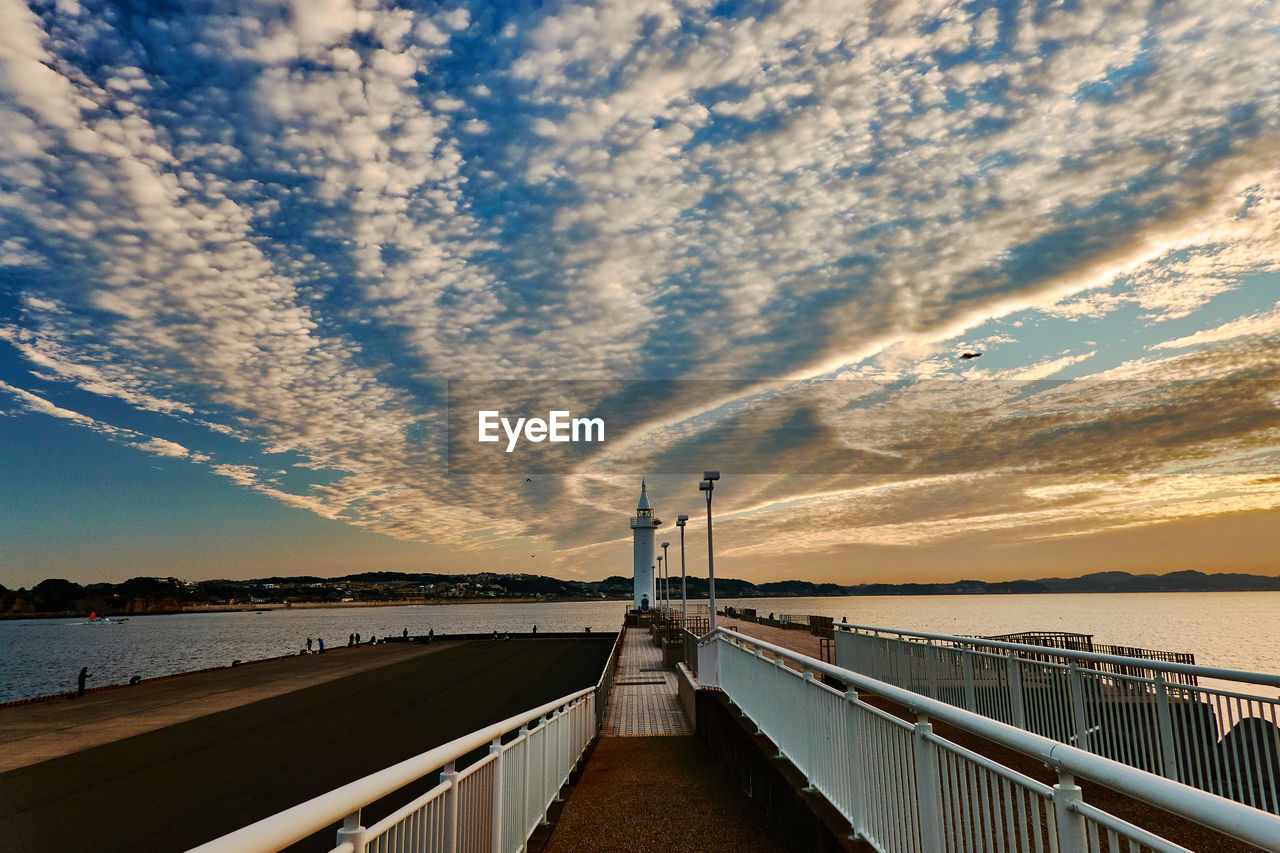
836, 624, 1280, 813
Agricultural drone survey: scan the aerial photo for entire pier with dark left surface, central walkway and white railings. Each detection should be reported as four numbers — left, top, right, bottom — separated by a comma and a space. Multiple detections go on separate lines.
0, 611, 1280, 853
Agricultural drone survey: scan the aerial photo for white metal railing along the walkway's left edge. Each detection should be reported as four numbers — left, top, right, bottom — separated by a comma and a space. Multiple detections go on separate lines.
191, 634, 621, 853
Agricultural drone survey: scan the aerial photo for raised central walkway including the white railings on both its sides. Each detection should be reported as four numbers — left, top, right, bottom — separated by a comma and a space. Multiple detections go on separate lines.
175, 604, 1280, 853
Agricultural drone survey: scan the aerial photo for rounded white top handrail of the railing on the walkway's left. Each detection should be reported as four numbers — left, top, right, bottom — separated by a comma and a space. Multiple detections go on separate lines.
189, 686, 595, 853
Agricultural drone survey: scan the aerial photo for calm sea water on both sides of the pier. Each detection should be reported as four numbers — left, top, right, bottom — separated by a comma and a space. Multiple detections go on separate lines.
0, 592, 1280, 702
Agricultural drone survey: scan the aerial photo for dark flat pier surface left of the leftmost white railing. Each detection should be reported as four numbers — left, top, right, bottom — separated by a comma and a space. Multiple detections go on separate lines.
0, 634, 613, 852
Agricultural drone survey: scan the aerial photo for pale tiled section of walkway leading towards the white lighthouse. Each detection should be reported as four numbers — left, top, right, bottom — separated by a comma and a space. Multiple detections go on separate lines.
600, 628, 694, 738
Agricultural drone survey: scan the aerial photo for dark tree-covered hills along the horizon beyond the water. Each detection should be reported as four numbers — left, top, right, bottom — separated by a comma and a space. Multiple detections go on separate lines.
0, 571, 1280, 617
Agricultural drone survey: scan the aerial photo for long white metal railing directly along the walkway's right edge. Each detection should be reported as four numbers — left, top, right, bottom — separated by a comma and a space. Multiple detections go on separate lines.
698, 628, 1280, 853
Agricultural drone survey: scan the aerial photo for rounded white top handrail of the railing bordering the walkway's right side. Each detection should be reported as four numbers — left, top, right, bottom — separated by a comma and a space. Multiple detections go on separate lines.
703, 628, 1280, 850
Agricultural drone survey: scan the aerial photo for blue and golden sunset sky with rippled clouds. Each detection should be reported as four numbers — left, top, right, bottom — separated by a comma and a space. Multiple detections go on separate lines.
0, 0, 1280, 588
